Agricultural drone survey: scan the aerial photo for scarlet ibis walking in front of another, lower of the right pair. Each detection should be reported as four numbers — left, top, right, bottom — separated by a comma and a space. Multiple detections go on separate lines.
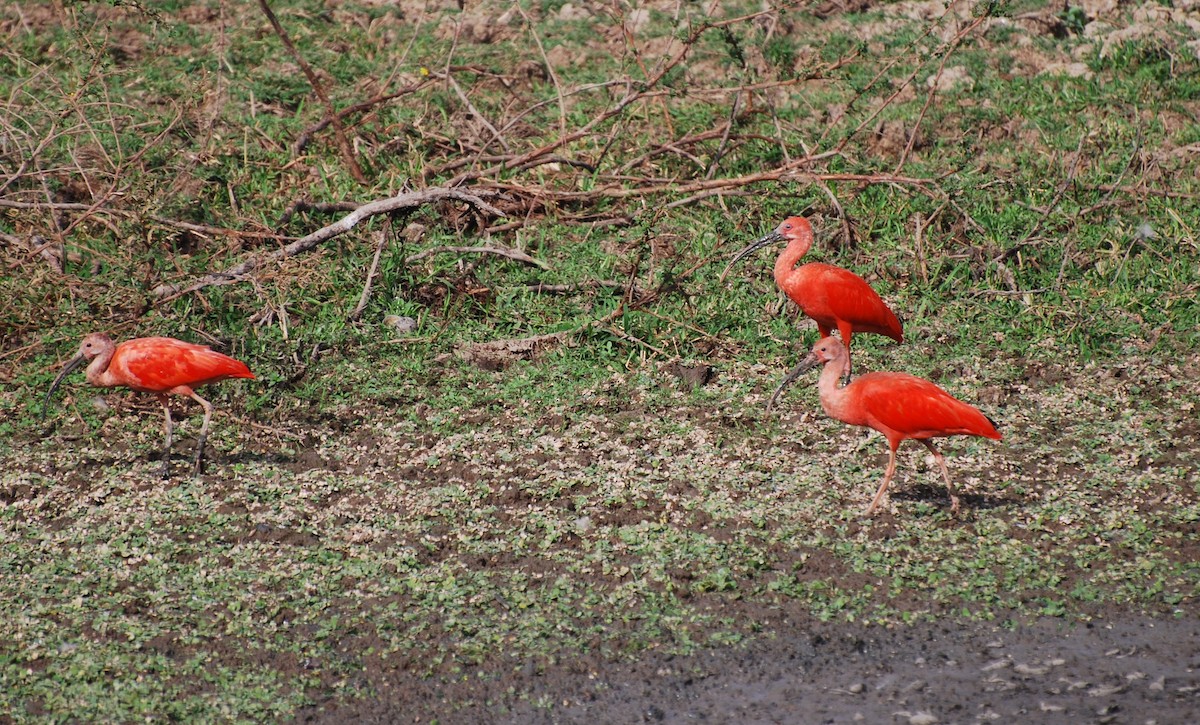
788, 337, 1000, 515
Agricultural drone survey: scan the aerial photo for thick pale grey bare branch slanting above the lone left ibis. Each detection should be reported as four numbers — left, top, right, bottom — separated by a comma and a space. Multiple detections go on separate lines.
152, 187, 504, 302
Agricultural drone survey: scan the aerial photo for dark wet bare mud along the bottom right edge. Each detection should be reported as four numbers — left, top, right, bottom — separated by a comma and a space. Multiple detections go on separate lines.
300, 613, 1200, 725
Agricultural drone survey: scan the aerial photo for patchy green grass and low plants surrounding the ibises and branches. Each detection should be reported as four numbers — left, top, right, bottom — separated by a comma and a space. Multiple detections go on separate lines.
0, 2, 1200, 720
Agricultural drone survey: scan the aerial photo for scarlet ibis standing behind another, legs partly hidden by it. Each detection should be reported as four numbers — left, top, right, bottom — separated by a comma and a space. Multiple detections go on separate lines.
721, 216, 904, 408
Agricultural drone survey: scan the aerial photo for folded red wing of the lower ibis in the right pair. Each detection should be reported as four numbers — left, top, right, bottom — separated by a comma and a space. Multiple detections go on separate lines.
854, 372, 1000, 438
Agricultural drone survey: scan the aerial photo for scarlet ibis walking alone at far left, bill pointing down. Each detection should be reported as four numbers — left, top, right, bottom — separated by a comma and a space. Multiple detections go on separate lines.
42, 334, 254, 478
